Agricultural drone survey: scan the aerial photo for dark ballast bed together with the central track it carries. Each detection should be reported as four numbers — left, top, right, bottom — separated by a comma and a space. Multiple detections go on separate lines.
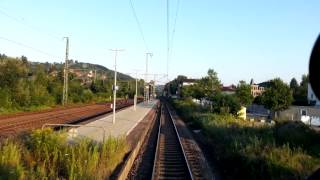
127, 102, 213, 179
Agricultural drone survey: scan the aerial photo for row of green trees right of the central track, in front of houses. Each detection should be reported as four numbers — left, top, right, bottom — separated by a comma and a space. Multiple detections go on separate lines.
166, 69, 308, 114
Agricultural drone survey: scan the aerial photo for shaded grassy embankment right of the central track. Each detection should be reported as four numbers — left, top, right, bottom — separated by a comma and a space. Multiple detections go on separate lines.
172, 100, 320, 179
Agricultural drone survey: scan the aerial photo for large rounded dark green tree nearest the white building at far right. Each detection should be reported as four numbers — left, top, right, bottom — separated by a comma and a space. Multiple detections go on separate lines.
262, 78, 293, 116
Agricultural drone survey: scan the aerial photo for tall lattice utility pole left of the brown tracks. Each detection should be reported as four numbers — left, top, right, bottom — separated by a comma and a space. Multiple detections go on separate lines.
62, 37, 69, 106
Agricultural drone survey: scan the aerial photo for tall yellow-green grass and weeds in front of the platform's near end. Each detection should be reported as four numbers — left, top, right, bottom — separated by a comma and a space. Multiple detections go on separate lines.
0, 129, 127, 179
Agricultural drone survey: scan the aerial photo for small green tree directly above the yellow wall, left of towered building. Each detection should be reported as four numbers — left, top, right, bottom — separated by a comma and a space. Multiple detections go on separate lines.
235, 81, 253, 106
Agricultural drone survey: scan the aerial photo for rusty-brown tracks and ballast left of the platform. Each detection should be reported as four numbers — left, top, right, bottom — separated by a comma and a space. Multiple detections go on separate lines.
0, 100, 142, 137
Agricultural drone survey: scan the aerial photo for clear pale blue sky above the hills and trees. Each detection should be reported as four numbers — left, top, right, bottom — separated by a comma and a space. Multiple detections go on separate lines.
0, 0, 320, 85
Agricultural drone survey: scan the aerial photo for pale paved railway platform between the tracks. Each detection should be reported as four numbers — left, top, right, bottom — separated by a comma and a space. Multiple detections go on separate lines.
73, 100, 158, 142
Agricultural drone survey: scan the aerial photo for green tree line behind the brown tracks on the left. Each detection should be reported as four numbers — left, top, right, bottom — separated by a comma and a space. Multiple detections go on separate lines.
0, 54, 144, 113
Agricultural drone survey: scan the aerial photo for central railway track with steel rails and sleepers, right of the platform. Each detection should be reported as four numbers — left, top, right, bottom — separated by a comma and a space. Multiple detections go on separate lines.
152, 103, 194, 180
